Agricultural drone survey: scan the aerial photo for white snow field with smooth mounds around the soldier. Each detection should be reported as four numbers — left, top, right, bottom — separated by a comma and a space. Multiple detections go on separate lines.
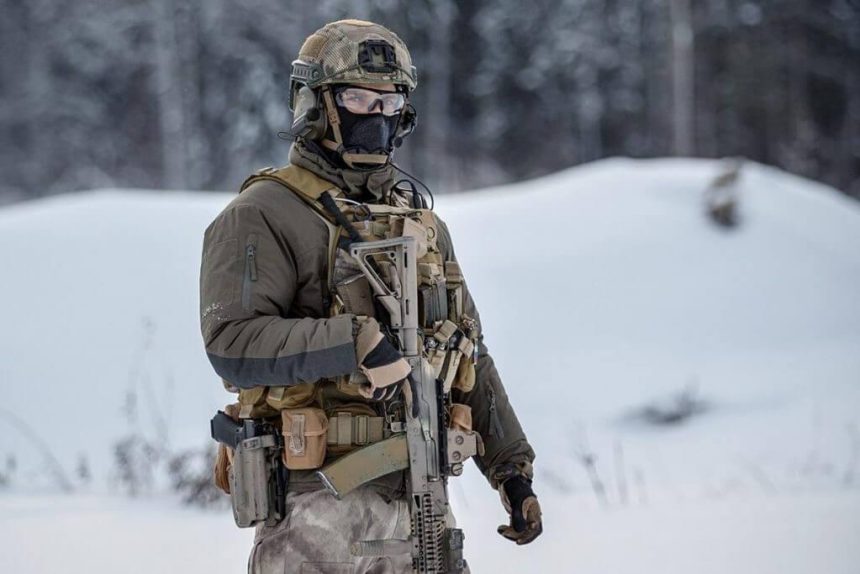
0, 159, 860, 574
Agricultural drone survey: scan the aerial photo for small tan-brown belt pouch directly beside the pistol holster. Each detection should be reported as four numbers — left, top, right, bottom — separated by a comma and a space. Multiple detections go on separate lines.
281, 407, 328, 470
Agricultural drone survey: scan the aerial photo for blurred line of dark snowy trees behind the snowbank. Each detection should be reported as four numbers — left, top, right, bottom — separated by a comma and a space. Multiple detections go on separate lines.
0, 0, 860, 201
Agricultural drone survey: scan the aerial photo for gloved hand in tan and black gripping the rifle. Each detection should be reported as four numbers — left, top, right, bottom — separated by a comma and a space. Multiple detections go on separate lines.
355, 317, 412, 401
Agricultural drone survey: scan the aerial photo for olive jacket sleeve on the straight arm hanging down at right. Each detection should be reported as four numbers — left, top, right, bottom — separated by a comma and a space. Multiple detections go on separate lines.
437, 217, 535, 488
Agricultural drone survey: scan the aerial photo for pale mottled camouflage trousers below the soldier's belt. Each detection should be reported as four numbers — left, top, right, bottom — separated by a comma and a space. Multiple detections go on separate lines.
248, 486, 412, 574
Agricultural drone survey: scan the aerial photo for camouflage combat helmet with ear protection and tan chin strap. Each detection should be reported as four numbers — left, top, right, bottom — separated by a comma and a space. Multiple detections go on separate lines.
289, 20, 417, 167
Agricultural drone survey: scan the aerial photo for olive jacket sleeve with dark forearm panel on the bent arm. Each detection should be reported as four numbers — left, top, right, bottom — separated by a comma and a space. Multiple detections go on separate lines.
200, 198, 356, 389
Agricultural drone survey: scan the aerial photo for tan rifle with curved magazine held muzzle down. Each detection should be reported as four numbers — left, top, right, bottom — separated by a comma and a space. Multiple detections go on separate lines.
317, 236, 478, 574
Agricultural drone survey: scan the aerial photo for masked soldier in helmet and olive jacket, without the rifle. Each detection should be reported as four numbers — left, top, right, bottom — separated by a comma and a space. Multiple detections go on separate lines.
200, 20, 542, 573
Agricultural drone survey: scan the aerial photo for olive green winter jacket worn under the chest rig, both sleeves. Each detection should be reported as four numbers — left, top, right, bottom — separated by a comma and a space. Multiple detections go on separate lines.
200, 149, 534, 487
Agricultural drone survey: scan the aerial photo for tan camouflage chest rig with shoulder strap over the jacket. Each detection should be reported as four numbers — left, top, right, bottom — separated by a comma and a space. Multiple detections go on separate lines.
233, 166, 479, 436
